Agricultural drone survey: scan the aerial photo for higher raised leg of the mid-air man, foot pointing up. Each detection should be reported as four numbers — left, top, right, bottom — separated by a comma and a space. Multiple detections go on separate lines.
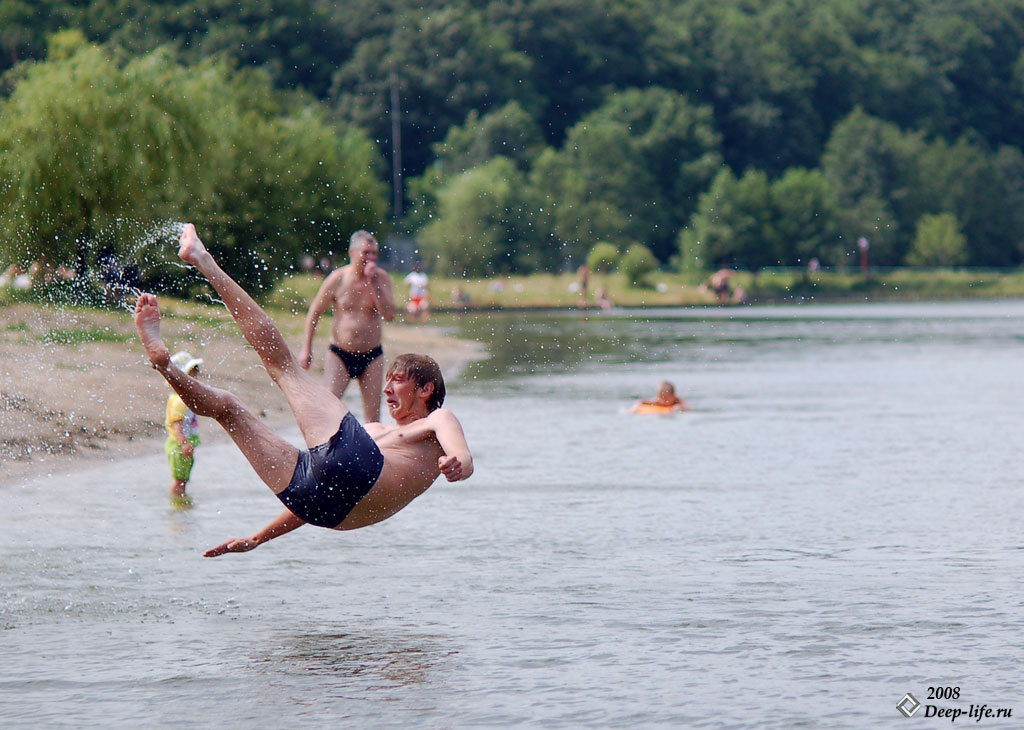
172, 223, 348, 446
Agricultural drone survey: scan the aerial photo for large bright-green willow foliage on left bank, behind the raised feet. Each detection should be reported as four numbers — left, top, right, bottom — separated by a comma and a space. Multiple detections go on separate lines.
0, 36, 386, 293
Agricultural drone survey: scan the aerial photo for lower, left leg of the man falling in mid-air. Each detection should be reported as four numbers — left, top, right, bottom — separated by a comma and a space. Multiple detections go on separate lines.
135, 294, 299, 493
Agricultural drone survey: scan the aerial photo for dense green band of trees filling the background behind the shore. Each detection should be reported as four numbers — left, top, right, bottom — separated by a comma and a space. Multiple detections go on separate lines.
0, 0, 1024, 285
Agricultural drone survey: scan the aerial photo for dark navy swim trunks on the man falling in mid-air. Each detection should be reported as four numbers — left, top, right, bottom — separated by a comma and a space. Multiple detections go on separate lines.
278, 414, 384, 527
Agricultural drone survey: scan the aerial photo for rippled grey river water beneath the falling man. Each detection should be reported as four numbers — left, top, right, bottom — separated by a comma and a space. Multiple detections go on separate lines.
0, 301, 1024, 729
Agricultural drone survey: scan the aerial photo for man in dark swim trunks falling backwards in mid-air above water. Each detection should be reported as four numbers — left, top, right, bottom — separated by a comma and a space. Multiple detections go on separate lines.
135, 223, 473, 558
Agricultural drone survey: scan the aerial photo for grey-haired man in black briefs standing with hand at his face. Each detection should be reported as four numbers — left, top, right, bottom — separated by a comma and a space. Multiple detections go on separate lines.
299, 230, 394, 423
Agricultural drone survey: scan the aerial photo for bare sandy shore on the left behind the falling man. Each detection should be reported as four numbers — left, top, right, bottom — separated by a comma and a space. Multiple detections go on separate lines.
0, 301, 483, 484
